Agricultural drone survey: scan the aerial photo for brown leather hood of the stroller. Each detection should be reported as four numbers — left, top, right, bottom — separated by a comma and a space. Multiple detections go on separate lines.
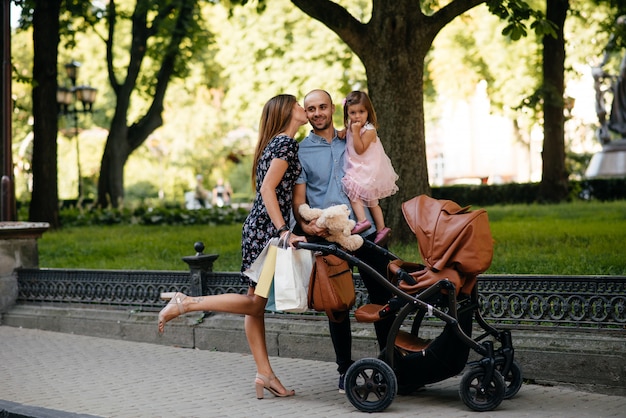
402, 195, 493, 293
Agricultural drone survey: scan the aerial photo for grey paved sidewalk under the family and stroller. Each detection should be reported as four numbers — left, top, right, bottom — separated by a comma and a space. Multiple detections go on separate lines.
0, 326, 626, 418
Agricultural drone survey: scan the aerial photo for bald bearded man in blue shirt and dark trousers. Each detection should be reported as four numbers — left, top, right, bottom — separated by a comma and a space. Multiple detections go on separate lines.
293, 90, 393, 393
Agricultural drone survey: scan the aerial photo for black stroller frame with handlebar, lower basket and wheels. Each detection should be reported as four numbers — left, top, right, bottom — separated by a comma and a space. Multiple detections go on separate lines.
298, 225, 522, 412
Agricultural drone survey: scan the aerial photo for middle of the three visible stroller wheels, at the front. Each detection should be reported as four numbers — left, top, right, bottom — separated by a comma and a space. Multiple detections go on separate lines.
459, 366, 505, 412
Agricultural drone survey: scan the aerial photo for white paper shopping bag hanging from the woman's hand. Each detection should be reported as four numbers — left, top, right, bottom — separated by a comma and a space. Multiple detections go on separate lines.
274, 244, 313, 313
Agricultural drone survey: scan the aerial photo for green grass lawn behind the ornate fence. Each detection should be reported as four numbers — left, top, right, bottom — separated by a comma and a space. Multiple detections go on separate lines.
39, 201, 626, 275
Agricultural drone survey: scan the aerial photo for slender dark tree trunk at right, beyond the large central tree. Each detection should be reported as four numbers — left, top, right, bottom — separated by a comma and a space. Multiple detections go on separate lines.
539, 0, 569, 202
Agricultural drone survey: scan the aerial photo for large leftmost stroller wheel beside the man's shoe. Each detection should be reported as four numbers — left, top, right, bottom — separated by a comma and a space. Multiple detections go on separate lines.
345, 358, 398, 412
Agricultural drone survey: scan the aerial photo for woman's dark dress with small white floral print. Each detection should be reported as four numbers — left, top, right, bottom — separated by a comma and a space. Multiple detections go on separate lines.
241, 135, 302, 280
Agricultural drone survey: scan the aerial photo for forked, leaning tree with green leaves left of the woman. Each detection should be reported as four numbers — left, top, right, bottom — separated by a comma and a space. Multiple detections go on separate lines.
98, 0, 209, 207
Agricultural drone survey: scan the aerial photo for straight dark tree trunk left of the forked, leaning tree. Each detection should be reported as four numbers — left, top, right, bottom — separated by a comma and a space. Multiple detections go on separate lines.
28, 0, 61, 228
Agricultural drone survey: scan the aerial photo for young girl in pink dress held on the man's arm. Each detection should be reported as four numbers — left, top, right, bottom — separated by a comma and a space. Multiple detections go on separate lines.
342, 91, 398, 245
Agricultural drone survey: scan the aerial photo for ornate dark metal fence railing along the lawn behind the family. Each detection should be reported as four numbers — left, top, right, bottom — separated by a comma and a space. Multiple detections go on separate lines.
17, 266, 626, 333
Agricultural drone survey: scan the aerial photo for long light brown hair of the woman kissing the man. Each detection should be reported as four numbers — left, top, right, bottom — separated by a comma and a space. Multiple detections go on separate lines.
252, 94, 297, 190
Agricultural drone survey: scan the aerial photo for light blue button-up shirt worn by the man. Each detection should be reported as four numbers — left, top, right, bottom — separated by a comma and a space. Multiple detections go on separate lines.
296, 130, 376, 236
